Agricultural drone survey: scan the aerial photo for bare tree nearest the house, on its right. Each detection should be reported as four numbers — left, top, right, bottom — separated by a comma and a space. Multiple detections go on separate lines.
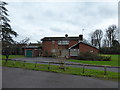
91, 29, 103, 48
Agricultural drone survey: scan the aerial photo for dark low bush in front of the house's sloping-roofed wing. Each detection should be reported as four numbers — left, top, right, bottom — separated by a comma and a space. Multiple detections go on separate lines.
77, 52, 111, 61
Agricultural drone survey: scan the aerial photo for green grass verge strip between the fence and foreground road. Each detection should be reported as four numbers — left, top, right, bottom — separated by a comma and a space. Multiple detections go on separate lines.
2, 60, 120, 81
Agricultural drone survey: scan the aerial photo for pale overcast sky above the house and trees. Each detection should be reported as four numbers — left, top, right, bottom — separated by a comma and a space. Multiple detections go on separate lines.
5, 0, 118, 42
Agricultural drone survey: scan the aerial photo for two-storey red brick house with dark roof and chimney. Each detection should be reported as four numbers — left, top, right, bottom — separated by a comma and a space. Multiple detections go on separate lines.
42, 34, 99, 57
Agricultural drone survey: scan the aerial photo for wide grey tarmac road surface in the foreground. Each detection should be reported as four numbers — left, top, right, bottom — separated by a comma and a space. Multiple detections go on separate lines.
2, 67, 118, 88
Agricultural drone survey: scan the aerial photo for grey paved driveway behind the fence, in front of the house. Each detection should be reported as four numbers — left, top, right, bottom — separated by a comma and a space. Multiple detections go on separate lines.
12, 57, 120, 72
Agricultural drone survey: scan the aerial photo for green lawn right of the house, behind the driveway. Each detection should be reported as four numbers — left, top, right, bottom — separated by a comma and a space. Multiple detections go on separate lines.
68, 55, 120, 66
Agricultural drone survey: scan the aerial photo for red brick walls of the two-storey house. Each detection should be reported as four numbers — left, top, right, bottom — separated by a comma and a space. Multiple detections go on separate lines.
42, 40, 98, 56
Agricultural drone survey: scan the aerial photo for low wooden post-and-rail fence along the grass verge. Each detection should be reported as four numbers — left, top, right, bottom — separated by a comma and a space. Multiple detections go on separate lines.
1, 59, 120, 75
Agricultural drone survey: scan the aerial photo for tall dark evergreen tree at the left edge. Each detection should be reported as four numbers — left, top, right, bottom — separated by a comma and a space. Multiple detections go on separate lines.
0, 1, 18, 57
